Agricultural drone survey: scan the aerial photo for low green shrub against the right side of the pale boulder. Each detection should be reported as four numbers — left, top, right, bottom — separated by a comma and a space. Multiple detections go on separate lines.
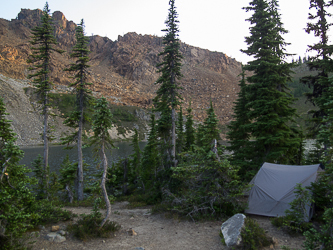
241, 217, 273, 250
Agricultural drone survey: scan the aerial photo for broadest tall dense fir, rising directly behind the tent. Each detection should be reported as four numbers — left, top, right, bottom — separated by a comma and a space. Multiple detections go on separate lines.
242, 0, 301, 177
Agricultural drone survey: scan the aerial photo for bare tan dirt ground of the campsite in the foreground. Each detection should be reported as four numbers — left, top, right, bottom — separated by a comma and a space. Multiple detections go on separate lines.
32, 202, 304, 250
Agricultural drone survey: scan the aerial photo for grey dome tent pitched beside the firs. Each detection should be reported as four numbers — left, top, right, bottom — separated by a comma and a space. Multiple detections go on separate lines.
245, 162, 321, 220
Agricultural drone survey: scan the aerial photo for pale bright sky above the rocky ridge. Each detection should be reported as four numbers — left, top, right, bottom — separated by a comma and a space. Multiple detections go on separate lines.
0, 0, 333, 63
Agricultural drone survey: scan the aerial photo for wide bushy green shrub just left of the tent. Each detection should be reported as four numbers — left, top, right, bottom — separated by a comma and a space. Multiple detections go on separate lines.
169, 147, 244, 220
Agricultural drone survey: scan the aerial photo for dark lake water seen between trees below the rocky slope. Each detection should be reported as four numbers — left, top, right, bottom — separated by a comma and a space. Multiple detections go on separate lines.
20, 142, 147, 173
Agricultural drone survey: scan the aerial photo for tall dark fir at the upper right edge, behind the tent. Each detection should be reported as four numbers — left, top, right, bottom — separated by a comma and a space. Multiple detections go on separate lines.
301, 0, 333, 156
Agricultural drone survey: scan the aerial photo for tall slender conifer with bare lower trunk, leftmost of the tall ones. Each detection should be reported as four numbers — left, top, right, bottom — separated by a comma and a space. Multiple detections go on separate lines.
27, 2, 63, 189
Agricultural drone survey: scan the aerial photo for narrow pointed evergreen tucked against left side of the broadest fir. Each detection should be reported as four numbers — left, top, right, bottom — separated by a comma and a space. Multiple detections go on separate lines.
227, 69, 250, 176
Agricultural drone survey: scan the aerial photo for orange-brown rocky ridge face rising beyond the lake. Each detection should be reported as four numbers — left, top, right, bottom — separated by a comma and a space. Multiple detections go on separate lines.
0, 9, 241, 127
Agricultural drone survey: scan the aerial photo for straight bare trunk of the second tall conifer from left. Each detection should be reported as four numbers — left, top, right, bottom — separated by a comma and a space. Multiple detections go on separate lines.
76, 89, 84, 201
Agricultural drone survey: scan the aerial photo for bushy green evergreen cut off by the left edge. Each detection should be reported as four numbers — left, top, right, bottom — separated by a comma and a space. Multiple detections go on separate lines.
0, 98, 38, 249
